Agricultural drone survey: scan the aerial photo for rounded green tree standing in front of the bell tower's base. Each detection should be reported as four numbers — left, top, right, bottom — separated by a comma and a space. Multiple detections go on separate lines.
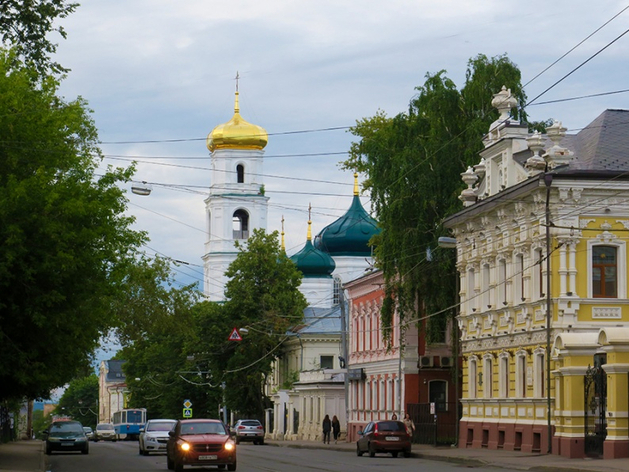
197, 230, 307, 418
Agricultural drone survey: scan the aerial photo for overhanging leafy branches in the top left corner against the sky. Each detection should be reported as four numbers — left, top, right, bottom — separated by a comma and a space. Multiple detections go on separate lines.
0, 0, 79, 74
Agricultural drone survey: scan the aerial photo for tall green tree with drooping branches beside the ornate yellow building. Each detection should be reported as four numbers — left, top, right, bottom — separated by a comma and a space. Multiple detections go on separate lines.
343, 55, 526, 341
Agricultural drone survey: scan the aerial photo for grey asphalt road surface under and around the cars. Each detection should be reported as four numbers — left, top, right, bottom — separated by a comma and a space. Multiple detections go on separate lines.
46, 441, 524, 472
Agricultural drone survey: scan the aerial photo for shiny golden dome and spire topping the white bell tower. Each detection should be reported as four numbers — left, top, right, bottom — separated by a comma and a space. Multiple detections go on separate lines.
206, 92, 269, 152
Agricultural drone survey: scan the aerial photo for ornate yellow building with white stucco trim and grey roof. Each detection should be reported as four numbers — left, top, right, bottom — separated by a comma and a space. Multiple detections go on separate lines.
445, 88, 629, 458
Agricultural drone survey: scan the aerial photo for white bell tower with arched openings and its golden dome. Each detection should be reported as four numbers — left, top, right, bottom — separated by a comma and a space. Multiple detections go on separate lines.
203, 85, 269, 301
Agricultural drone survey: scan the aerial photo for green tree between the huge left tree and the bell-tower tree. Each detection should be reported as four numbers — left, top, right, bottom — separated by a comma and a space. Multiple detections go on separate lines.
113, 258, 217, 418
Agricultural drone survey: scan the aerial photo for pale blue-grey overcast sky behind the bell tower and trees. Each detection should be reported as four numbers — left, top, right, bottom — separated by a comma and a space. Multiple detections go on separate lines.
50, 0, 629, 289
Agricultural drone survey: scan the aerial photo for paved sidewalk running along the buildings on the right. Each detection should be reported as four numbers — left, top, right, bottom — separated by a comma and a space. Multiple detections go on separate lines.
265, 440, 629, 472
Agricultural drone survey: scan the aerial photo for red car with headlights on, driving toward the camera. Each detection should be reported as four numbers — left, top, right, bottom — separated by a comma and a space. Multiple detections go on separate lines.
166, 419, 236, 472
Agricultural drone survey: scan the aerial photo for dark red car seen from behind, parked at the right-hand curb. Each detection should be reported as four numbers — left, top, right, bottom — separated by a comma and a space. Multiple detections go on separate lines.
356, 421, 411, 457
